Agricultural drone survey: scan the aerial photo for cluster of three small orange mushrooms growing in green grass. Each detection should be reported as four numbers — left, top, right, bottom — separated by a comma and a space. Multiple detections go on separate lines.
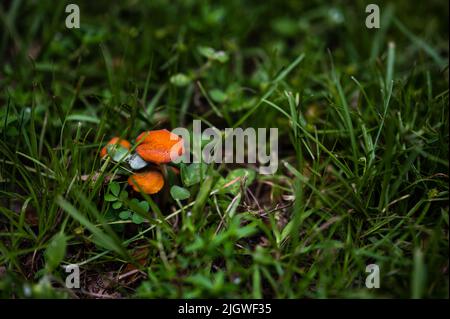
100, 129, 184, 194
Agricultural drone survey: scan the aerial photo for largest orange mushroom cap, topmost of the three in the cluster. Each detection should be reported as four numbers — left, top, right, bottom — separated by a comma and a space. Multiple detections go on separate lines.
136, 129, 183, 164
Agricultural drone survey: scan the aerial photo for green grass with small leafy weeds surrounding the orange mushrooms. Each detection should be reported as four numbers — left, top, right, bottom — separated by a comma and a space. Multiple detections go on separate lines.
0, 0, 449, 298
